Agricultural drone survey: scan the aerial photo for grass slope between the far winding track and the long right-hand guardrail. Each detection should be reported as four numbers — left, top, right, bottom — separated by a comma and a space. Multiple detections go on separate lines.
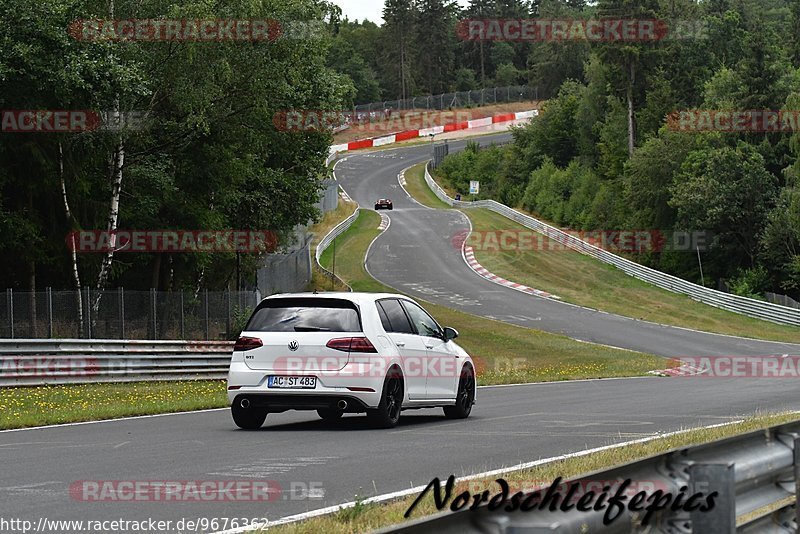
406, 165, 800, 343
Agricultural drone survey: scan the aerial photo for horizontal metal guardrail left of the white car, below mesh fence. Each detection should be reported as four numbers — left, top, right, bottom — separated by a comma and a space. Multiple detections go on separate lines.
0, 339, 233, 387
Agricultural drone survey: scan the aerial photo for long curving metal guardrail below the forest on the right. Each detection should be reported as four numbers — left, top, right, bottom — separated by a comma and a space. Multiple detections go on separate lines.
425, 165, 800, 326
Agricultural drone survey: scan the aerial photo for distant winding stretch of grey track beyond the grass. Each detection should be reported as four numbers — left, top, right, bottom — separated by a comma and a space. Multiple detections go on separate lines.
336, 134, 800, 356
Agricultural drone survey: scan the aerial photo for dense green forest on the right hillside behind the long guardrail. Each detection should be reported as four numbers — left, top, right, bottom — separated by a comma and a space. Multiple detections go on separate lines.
441, 0, 800, 298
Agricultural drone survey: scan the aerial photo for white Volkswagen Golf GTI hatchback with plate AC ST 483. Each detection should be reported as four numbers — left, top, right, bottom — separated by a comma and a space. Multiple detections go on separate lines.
228, 293, 476, 430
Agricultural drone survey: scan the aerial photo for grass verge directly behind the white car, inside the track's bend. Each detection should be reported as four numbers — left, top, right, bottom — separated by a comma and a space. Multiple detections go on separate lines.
321, 210, 666, 385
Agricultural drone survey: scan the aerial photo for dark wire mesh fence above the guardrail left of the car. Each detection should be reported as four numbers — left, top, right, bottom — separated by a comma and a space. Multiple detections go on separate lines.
0, 287, 261, 340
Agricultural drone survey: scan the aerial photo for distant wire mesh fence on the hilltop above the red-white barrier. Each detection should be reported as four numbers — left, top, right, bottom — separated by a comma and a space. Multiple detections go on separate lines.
354, 85, 539, 116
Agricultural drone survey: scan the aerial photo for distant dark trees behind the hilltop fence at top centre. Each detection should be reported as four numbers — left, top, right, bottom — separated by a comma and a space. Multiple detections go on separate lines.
328, 0, 540, 104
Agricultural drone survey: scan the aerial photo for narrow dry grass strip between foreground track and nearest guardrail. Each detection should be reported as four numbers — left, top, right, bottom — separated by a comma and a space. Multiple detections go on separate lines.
269, 413, 798, 534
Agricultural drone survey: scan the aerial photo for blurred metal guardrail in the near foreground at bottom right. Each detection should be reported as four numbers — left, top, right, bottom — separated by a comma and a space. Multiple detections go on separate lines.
380, 421, 800, 534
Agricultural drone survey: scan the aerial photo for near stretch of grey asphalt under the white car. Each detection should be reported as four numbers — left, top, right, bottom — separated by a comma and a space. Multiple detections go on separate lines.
0, 378, 800, 522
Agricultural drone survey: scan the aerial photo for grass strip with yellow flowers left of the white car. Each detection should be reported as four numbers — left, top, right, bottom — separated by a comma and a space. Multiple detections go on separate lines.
0, 380, 228, 430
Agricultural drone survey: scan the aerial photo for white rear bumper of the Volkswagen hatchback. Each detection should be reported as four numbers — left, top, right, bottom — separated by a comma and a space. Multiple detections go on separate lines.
228, 362, 383, 411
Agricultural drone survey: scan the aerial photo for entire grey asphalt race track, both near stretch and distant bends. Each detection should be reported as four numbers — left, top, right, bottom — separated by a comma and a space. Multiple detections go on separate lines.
0, 134, 800, 532
